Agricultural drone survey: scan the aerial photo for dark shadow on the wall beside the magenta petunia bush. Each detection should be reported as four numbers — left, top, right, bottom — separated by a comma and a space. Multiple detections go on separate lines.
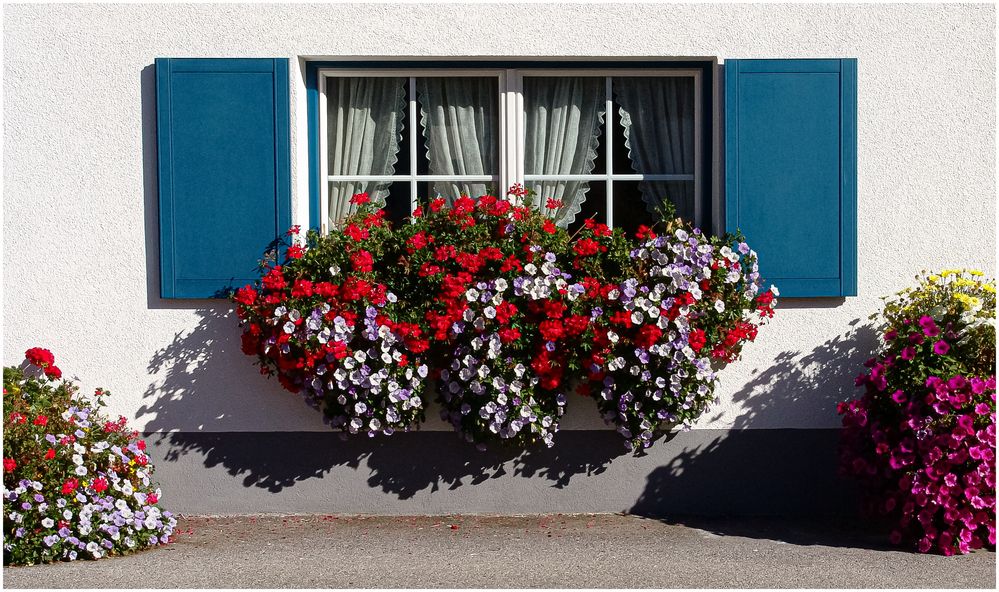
629, 320, 876, 544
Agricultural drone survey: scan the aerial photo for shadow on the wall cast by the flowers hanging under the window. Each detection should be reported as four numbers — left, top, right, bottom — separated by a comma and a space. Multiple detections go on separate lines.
138, 303, 625, 499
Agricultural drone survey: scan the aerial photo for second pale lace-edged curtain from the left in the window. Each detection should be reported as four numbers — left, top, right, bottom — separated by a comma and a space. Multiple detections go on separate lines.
416, 77, 499, 200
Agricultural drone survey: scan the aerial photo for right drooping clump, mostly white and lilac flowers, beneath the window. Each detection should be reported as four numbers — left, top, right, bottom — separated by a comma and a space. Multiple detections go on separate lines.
587, 223, 777, 451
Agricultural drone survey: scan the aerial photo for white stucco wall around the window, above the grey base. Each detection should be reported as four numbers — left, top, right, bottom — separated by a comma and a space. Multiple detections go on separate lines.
3, 4, 996, 431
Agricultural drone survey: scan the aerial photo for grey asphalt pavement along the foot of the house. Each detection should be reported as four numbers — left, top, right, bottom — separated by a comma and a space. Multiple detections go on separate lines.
3, 514, 996, 589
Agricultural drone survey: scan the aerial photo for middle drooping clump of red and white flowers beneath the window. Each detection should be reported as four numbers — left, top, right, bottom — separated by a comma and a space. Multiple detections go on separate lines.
388, 188, 588, 447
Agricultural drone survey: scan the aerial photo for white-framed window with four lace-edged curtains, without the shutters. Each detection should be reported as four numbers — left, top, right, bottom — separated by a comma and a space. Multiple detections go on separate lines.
317, 67, 711, 236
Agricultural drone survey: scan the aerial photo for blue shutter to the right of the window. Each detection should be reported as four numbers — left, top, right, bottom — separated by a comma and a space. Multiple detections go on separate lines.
725, 59, 857, 297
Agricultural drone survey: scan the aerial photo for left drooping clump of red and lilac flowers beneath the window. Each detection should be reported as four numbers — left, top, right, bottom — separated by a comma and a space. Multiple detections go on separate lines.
234, 194, 429, 436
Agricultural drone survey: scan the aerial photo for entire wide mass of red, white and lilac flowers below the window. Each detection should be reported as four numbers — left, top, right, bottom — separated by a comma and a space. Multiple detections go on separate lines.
234, 186, 776, 450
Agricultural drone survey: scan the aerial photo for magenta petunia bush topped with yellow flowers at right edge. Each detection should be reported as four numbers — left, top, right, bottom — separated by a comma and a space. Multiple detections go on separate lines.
839, 270, 996, 555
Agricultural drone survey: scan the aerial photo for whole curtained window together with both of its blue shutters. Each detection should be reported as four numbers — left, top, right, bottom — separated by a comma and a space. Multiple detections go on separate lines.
156, 58, 857, 299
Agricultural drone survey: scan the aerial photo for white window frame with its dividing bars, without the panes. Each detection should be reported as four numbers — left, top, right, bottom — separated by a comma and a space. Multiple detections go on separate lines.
318, 67, 705, 229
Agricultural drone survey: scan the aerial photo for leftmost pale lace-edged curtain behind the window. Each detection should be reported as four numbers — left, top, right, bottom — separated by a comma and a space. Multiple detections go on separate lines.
326, 77, 406, 225
